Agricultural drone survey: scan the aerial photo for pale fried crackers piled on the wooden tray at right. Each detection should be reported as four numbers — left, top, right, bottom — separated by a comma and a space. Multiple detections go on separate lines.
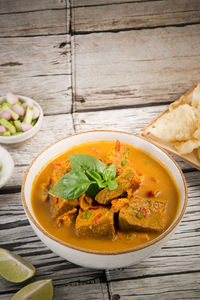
142, 84, 200, 160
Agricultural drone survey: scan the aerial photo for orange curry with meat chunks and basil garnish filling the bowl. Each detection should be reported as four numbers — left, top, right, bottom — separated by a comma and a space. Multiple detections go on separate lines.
31, 140, 180, 252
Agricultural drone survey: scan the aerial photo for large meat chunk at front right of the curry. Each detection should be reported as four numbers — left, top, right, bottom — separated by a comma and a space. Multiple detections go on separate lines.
119, 196, 166, 231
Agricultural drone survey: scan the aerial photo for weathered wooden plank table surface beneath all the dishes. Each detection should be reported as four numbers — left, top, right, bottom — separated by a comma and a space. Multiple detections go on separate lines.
0, 0, 200, 300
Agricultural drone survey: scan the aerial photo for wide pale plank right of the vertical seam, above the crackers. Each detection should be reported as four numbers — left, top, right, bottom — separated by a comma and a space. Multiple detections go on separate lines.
73, 25, 200, 111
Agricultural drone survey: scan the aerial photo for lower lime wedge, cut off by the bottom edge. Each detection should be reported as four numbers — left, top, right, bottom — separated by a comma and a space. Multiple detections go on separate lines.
10, 279, 53, 300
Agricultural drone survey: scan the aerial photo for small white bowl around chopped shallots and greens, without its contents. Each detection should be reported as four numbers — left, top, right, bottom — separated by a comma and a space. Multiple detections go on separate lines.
0, 95, 43, 145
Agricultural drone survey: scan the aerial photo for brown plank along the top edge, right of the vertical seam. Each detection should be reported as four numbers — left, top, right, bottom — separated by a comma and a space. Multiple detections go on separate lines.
72, 0, 200, 33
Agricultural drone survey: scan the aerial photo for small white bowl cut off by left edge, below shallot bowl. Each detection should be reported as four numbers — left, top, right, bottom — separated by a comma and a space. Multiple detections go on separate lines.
0, 146, 14, 188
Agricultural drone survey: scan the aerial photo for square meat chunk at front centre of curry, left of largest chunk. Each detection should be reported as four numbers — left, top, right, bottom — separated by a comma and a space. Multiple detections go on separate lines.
75, 207, 115, 239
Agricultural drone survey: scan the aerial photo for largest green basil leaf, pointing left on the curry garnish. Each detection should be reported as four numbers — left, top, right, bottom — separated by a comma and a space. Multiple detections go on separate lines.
49, 171, 94, 199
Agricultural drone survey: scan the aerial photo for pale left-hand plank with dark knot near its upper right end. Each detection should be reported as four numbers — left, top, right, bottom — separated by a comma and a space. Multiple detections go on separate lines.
0, 35, 70, 77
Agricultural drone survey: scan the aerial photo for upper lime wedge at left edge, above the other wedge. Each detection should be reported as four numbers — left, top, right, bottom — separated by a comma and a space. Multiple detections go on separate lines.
0, 248, 35, 282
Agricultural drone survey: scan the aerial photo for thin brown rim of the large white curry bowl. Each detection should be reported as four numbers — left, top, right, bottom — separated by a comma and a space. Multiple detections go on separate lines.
21, 130, 188, 255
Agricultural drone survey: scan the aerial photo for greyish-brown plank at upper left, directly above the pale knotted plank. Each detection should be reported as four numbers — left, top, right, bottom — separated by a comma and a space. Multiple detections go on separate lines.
0, 9, 69, 37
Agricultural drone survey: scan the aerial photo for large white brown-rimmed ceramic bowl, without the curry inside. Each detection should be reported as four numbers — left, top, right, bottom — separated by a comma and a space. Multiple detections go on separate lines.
22, 130, 187, 269
